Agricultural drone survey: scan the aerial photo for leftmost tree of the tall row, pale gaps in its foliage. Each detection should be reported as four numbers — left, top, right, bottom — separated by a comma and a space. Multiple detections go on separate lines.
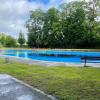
26, 9, 44, 47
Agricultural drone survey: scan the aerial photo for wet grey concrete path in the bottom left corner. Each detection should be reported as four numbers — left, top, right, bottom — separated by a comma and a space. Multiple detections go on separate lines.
0, 74, 56, 100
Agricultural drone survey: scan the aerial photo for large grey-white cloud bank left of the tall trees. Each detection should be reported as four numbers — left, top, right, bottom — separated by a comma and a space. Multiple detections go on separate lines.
0, 0, 42, 35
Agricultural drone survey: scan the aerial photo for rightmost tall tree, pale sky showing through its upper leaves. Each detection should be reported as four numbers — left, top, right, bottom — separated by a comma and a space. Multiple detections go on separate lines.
81, 0, 100, 48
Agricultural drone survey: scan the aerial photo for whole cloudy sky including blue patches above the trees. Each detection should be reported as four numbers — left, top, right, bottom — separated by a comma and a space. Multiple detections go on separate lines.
0, 0, 77, 37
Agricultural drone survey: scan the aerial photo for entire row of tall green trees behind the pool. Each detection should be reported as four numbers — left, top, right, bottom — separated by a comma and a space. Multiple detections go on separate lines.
26, 0, 100, 48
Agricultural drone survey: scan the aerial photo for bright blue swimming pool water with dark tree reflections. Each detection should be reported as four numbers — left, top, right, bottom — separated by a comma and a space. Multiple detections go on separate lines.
2, 50, 100, 63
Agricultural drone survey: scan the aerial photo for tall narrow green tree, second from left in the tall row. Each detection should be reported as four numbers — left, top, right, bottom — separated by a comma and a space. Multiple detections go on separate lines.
43, 8, 60, 48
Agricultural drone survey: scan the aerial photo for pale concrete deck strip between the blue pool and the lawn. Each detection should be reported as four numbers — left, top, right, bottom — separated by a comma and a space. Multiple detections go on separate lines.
0, 55, 100, 68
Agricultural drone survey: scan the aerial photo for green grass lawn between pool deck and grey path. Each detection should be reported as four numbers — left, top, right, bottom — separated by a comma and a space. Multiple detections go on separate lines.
0, 59, 100, 100
